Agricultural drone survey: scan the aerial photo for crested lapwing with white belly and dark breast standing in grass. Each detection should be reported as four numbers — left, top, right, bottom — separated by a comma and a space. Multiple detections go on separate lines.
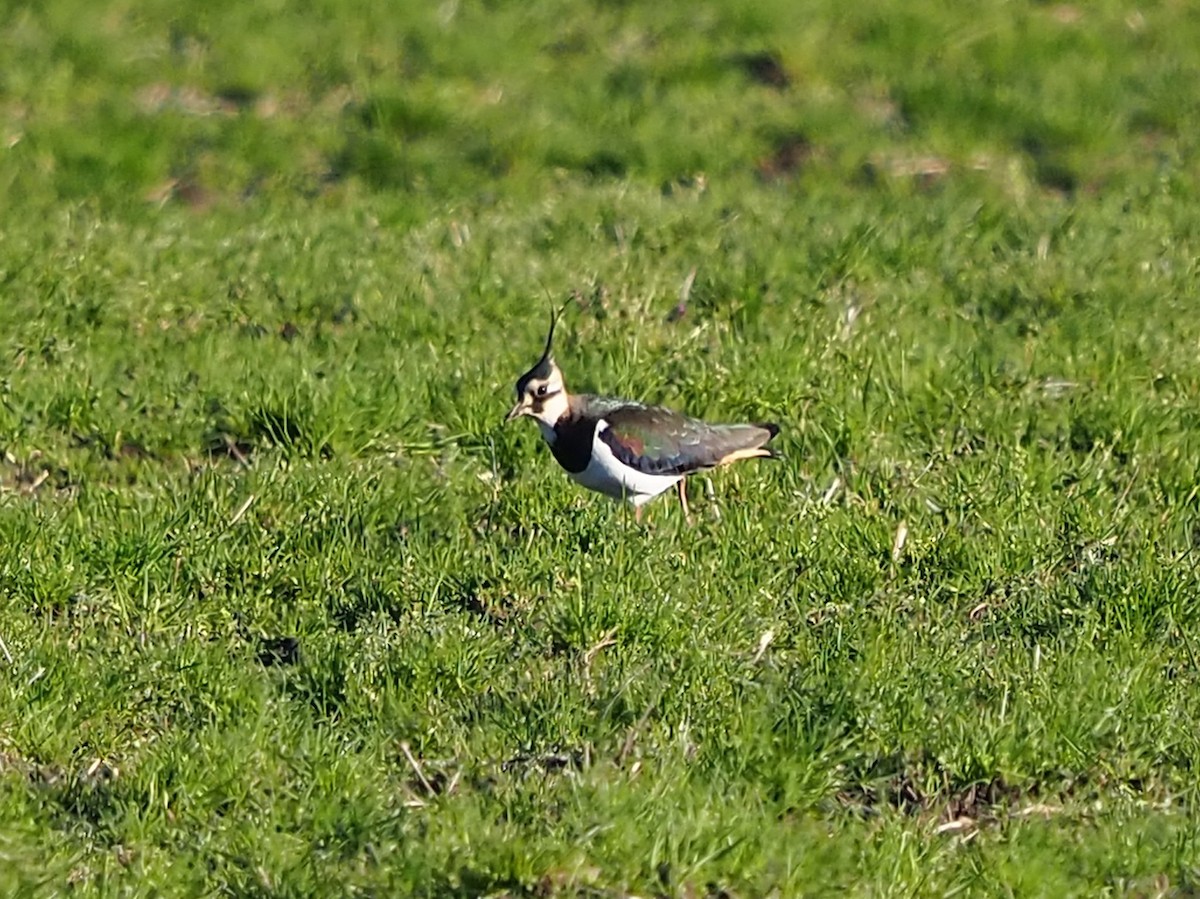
504, 310, 779, 522
